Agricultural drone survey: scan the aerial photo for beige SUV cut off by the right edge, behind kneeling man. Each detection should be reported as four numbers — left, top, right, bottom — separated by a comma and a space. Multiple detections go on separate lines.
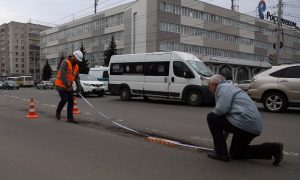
248, 64, 300, 112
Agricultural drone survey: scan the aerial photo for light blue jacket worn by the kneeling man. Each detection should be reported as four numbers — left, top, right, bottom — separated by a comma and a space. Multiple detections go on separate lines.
213, 81, 262, 135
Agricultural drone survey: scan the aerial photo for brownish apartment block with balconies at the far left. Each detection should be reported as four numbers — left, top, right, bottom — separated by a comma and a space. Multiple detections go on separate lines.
0, 22, 50, 79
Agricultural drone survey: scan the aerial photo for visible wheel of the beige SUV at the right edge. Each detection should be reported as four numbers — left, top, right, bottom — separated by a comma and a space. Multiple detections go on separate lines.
263, 92, 287, 112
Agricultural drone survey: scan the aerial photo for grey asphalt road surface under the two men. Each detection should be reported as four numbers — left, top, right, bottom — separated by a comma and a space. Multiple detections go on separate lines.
0, 88, 300, 180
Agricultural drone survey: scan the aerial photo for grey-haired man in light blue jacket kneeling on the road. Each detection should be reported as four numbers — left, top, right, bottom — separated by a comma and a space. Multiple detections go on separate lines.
207, 75, 283, 165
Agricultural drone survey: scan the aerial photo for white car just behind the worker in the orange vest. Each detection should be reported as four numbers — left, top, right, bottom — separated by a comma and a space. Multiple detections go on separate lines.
73, 74, 106, 97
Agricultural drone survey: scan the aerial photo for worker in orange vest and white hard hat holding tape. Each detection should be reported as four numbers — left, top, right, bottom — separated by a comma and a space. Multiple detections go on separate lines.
55, 51, 83, 123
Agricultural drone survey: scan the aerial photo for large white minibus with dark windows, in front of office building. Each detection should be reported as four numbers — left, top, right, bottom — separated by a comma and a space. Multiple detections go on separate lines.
108, 51, 214, 106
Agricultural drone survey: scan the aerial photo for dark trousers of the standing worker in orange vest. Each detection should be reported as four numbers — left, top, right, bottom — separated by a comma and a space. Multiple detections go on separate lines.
56, 89, 74, 119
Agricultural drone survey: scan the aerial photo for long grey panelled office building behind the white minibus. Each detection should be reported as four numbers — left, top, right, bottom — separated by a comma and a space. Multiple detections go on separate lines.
41, 0, 300, 81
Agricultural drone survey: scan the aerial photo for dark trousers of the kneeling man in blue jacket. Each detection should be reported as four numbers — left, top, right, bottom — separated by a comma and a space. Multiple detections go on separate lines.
207, 112, 273, 159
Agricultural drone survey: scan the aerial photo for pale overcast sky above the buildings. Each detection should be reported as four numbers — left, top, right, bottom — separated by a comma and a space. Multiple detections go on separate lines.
0, 0, 300, 27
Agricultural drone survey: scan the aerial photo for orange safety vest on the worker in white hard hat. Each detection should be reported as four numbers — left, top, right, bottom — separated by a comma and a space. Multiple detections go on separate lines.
55, 59, 79, 88
